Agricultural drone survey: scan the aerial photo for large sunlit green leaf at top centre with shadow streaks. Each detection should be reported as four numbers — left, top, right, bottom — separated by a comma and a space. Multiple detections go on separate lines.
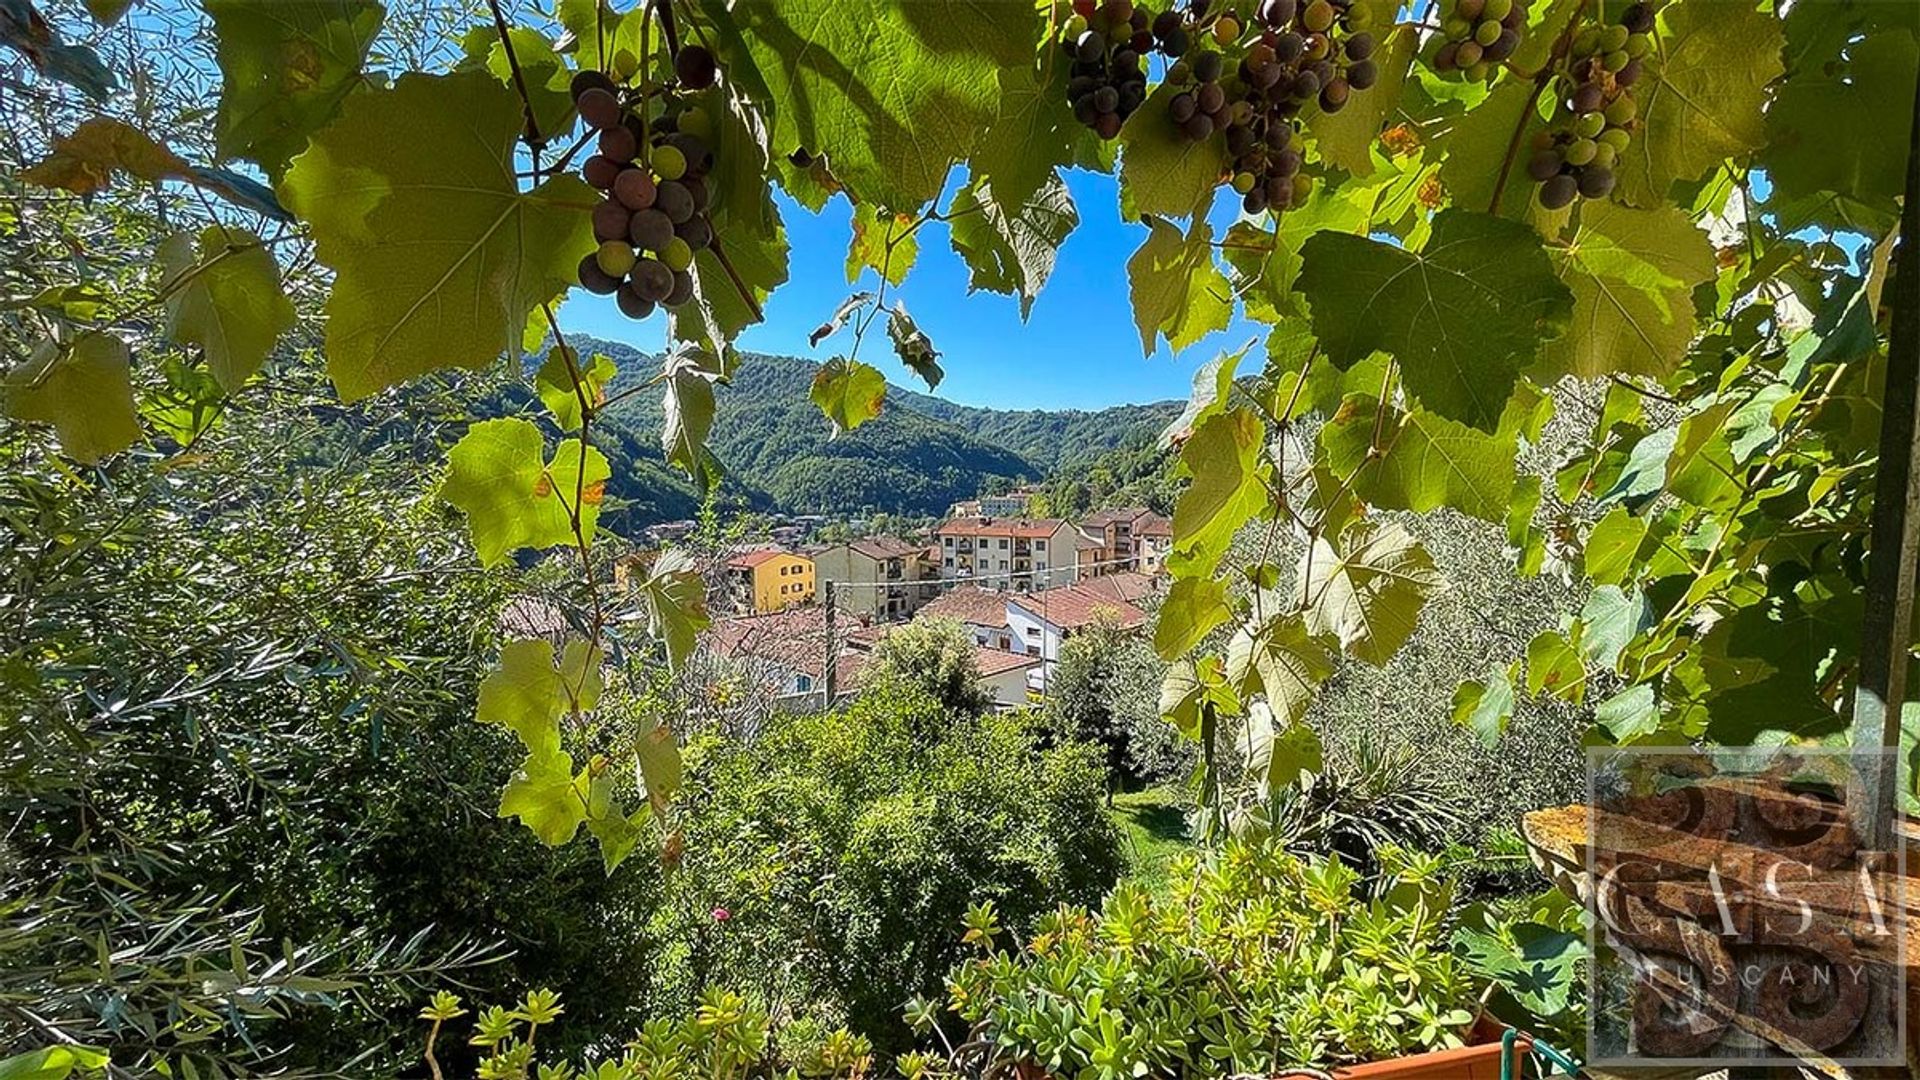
714, 0, 1039, 209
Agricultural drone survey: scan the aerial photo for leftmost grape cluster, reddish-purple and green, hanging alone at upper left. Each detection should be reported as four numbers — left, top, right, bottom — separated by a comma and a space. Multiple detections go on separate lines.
572, 44, 714, 319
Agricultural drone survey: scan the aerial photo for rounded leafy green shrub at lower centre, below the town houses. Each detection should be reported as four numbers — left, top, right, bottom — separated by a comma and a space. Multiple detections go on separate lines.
653, 680, 1121, 1049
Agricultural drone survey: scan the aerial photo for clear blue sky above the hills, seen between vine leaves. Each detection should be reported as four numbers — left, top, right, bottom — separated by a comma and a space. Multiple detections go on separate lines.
561, 171, 1263, 409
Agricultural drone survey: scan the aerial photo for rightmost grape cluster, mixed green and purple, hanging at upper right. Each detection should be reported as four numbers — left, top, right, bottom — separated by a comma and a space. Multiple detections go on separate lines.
1526, 4, 1653, 209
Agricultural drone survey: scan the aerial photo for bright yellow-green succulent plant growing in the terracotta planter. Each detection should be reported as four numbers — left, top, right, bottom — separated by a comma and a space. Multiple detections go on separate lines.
936, 842, 1476, 1080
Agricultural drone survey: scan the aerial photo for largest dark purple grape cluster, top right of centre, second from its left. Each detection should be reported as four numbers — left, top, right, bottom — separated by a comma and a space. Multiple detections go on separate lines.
1167, 0, 1379, 213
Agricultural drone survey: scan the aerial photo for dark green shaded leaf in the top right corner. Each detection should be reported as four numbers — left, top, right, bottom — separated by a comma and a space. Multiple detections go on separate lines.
1761, 29, 1920, 209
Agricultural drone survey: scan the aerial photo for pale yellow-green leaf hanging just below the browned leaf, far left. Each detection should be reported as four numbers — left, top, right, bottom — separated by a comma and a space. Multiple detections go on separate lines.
156, 225, 294, 394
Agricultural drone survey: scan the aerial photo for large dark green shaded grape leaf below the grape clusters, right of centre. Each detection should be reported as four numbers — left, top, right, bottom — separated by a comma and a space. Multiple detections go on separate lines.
1298, 209, 1572, 430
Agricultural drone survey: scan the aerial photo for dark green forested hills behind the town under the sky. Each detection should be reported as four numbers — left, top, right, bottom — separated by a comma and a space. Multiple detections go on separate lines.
572, 338, 1179, 528
